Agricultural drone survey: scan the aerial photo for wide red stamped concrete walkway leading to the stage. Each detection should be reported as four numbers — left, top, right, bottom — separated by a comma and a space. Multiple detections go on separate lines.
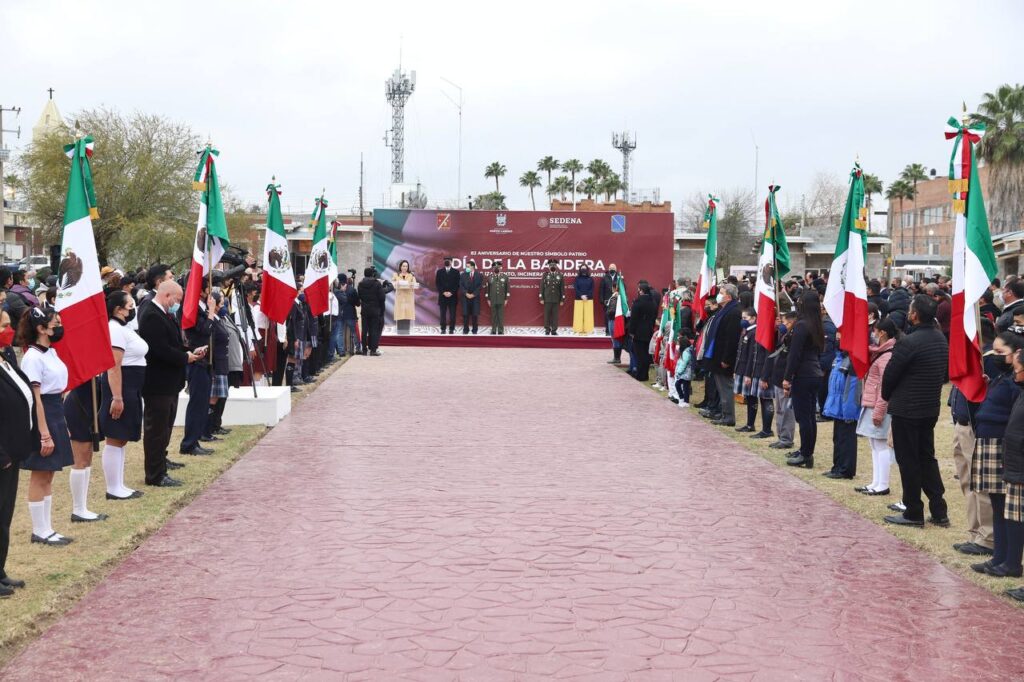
6, 348, 1024, 682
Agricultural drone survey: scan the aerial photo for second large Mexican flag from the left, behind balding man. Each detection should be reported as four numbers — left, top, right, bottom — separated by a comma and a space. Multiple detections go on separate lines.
181, 144, 227, 329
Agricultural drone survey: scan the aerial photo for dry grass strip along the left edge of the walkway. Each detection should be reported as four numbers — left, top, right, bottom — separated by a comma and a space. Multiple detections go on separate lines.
0, 360, 344, 666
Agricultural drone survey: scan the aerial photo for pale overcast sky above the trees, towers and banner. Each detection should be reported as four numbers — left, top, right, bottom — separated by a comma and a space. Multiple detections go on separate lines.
0, 0, 1024, 218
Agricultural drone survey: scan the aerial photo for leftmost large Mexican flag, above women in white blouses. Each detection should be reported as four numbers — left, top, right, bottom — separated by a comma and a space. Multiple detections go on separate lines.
53, 137, 114, 390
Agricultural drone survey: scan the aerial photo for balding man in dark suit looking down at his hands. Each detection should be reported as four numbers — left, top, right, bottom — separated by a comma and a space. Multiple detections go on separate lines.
138, 280, 205, 487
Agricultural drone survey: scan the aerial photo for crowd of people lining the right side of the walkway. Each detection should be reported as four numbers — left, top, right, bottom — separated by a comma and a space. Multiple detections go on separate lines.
602, 272, 1024, 601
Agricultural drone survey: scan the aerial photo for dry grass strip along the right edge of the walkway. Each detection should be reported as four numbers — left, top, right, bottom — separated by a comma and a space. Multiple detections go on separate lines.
648, 372, 1024, 608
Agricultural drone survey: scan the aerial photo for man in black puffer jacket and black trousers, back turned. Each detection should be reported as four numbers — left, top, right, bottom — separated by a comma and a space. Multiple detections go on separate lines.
882, 294, 949, 526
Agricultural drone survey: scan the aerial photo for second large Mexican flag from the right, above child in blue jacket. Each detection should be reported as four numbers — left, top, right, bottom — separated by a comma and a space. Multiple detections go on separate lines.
824, 164, 870, 379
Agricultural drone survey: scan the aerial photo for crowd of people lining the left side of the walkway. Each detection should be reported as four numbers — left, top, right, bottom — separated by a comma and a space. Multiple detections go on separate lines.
0, 254, 395, 597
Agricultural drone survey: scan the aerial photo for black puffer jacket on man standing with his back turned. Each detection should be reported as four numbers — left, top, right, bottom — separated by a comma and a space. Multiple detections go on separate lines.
882, 325, 949, 419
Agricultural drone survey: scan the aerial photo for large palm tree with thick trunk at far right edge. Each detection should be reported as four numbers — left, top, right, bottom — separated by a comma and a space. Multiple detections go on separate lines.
971, 84, 1024, 233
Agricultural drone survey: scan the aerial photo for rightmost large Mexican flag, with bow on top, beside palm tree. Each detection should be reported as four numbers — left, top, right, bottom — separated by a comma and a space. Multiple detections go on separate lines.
946, 118, 997, 402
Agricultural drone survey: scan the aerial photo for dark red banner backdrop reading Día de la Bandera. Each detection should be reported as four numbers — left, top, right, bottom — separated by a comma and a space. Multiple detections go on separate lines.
374, 209, 674, 329
